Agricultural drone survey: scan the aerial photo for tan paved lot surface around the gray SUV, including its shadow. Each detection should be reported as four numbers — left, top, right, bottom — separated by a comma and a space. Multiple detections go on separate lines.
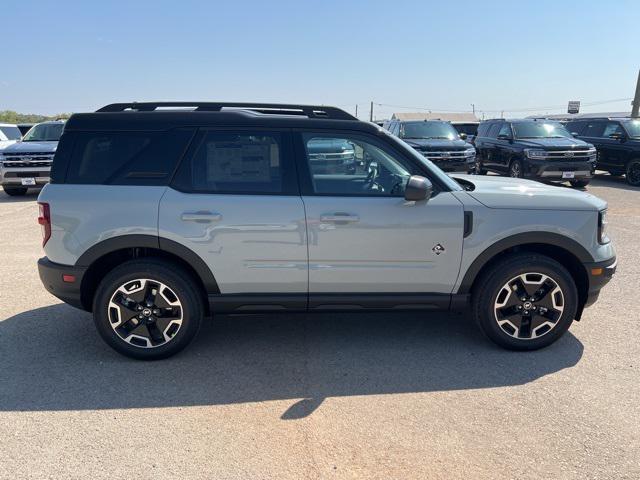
0, 175, 640, 479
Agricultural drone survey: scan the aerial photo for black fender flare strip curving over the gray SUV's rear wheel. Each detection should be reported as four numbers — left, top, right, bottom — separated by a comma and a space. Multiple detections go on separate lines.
75, 234, 220, 294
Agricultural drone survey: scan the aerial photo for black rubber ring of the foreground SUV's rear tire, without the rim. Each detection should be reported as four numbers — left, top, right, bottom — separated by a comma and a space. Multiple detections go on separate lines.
93, 261, 203, 360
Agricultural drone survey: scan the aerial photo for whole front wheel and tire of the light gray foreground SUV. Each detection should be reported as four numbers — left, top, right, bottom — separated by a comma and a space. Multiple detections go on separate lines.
472, 253, 578, 350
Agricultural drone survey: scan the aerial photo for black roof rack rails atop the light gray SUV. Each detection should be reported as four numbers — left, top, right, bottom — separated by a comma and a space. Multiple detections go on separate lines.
96, 102, 358, 120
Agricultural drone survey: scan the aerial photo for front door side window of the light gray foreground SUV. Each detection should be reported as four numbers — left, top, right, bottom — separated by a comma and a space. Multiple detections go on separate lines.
303, 134, 411, 197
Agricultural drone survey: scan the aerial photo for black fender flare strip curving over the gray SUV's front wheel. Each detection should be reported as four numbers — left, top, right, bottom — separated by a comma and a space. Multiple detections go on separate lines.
458, 232, 594, 293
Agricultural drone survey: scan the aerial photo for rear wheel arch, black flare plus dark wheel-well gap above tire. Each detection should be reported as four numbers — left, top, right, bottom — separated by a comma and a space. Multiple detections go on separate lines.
76, 235, 220, 313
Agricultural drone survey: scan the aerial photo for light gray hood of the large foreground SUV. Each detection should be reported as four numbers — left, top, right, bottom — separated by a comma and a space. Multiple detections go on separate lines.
451, 174, 607, 211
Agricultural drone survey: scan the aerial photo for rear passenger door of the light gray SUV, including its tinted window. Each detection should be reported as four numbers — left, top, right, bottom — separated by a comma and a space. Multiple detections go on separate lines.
159, 129, 308, 298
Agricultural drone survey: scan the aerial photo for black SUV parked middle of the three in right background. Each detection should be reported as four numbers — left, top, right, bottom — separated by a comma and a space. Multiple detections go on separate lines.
475, 119, 596, 187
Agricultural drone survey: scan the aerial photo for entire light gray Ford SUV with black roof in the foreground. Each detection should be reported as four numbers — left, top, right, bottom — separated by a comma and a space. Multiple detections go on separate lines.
38, 102, 616, 359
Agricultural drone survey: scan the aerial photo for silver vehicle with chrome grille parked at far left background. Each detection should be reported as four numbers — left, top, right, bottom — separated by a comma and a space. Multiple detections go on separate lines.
0, 121, 64, 195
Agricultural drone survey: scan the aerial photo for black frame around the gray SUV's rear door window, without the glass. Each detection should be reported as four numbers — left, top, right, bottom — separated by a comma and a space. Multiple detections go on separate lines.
168, 125, 300, 197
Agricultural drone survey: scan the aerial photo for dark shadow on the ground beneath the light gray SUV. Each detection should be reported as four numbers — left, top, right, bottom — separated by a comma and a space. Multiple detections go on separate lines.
0, 304, 583, 419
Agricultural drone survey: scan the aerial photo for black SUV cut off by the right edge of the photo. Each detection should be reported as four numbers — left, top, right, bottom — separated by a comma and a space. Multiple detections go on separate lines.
566, 118, 640, 187
